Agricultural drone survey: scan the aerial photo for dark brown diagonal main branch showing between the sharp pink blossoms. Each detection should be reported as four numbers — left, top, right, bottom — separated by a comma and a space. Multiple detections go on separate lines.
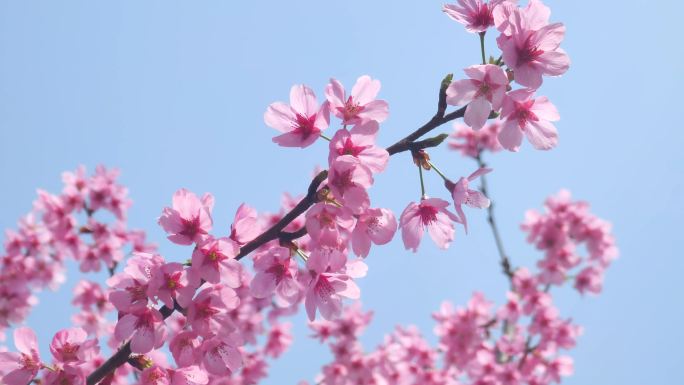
86, 74, 465, 385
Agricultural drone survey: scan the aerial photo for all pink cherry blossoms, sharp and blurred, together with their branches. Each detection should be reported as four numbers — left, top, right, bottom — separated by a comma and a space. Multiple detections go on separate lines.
0, 0, 617, 385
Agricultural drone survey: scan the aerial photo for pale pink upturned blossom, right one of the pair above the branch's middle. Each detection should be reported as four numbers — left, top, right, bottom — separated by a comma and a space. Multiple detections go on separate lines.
325, 75, 389, 125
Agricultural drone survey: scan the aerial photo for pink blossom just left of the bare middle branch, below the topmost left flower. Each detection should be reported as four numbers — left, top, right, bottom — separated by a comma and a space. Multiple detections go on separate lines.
189, 238, 242, 288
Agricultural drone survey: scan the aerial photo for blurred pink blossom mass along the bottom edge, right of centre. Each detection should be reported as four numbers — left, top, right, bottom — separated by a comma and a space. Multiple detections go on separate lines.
302, 288, 581, 385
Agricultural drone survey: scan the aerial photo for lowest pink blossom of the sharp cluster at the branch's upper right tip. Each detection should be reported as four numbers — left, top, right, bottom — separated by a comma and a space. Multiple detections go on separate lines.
499, 89, 560, 151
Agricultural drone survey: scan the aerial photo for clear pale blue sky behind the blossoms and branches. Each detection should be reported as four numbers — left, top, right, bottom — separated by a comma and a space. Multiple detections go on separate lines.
0, 0, 684, 385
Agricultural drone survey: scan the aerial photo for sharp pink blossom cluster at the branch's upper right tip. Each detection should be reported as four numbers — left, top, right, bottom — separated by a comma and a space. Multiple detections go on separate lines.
444, 0, 570, 151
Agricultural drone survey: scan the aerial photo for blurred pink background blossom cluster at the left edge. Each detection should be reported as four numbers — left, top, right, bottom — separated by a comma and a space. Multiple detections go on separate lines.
0, 166, 154, 334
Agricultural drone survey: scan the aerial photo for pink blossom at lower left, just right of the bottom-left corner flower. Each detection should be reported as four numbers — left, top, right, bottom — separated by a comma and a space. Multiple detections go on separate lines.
50, 328, 100, 363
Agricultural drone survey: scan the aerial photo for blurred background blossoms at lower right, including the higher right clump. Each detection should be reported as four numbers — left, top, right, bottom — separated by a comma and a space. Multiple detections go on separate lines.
302, 191, 617, 385
